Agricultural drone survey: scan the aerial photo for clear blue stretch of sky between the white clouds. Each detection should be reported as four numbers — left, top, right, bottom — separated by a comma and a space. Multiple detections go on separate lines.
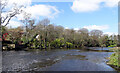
32, 2, 118, 33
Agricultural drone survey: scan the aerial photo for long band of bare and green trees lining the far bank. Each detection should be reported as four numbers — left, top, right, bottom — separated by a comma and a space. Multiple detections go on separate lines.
2, 19, 117, 49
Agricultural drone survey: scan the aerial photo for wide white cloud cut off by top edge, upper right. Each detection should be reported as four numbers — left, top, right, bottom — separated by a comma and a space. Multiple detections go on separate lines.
71, 0, 118, 13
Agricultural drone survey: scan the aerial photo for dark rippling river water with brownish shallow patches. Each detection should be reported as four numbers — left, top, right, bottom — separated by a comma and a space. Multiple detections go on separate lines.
2, 48, 115, 71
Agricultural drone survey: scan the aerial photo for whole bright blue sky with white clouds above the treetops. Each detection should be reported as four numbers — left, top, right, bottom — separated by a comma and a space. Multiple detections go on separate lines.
1, 0, 118, 35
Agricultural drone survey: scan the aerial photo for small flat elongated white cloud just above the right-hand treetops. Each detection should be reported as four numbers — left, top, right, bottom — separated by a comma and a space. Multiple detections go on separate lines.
83, 25, 109, 30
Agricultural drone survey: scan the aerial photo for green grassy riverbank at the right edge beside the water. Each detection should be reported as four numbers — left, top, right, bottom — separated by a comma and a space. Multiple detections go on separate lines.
106, 47, 120, 72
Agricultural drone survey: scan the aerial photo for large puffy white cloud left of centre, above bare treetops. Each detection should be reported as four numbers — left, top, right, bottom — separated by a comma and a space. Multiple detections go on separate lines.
25, 4, 60, 18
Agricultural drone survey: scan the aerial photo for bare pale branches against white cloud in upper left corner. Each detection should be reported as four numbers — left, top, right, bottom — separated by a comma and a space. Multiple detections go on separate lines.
0, 0, 24, 26
